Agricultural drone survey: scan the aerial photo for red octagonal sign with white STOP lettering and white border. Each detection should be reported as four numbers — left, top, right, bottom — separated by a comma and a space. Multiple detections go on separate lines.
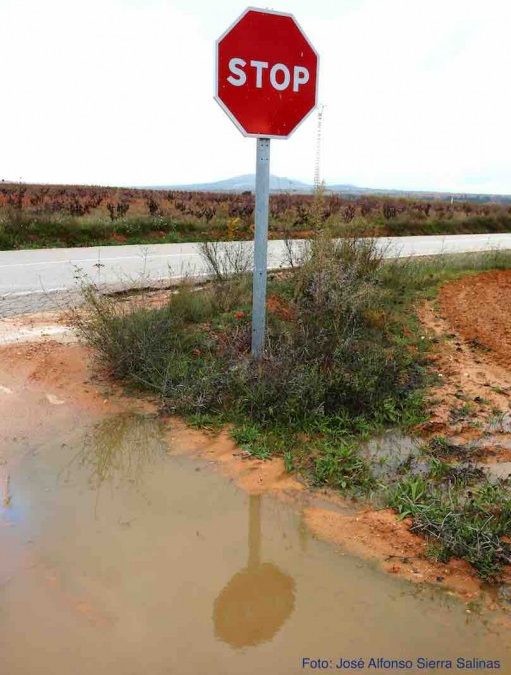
215, 8, 318, 138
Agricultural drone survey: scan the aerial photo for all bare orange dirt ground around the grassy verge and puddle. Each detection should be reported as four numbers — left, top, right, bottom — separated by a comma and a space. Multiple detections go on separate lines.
0, 272, 511, 600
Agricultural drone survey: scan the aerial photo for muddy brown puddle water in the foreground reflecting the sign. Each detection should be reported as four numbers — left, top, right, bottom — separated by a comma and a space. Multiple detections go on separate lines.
0, 403, 511, 675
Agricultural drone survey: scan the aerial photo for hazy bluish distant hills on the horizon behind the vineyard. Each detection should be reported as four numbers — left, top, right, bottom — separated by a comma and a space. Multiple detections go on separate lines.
146, 173, 511, 203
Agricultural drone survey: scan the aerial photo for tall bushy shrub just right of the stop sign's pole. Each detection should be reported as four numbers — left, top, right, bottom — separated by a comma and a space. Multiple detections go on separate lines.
224, 238, 419, 424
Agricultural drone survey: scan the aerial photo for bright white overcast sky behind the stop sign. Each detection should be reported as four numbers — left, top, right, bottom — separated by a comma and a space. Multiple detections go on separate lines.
0, 0, 511, 193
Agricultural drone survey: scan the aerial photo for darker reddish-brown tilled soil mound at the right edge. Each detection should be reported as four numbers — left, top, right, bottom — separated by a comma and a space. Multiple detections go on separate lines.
439, 270, 511, 366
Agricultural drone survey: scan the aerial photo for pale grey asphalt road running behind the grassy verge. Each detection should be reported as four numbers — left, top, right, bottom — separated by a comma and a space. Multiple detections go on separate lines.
0, 233, 511, 316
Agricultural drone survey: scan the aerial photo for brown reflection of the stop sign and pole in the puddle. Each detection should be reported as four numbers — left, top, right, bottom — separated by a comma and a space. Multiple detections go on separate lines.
213, 495, 295, 647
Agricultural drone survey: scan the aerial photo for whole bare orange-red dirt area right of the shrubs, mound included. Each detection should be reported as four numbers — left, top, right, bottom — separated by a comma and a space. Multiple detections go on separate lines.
420, 271, 511, 462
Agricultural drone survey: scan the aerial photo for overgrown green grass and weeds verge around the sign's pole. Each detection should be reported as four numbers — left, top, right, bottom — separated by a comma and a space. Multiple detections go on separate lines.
76, 235, 511, 578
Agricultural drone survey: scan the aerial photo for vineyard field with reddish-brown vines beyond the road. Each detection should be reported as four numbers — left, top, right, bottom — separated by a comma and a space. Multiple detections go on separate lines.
0, 183, 511, 250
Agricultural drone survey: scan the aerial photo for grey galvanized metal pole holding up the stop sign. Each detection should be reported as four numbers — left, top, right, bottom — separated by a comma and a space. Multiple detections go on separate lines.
252, 138, 270, 359
